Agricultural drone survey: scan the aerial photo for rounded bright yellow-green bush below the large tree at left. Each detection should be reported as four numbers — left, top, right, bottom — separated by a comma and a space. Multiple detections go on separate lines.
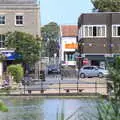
7, 64, 24, 83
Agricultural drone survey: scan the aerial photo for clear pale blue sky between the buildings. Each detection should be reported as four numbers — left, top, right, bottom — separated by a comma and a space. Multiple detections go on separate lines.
40, 0, 93, 25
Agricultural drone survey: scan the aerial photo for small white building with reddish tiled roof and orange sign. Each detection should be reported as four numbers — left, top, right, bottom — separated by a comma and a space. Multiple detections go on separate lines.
60, 25, 77, 66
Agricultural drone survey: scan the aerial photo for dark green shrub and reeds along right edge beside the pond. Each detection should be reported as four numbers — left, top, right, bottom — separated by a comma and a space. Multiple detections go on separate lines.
97, 56, 120, 120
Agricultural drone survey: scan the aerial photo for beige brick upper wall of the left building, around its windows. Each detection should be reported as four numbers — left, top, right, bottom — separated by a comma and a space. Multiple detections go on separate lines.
0, 5, 40, 36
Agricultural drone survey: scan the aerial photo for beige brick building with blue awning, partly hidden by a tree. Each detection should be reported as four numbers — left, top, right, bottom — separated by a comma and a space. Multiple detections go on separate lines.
0, 0, 40, 80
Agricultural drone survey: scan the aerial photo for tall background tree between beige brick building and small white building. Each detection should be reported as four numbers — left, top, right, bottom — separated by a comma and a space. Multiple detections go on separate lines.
41, 22, 60, 57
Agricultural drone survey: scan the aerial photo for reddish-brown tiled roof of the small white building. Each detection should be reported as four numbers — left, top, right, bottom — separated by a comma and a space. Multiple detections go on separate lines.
61, 25, 77, 37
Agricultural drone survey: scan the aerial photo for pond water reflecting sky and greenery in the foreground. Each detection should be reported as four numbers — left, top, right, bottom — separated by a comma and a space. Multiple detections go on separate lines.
0, 97, 97, 120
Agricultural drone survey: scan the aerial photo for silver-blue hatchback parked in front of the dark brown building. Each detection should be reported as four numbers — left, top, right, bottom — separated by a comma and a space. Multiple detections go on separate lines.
79, 66, 109, 78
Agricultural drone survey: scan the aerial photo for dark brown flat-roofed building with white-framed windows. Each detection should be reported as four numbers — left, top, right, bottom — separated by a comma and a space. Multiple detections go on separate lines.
78, 12, 120, 67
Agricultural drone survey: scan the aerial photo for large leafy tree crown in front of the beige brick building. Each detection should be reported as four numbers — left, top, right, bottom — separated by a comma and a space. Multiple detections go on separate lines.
6, 31, 40, 64
